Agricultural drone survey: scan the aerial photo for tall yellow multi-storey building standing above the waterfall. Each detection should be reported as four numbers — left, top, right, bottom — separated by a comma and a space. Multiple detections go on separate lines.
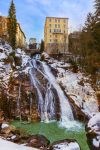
44, 17, 68, 54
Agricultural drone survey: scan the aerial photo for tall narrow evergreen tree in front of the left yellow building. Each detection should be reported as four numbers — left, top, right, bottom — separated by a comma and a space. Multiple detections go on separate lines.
8, 0, 17, 49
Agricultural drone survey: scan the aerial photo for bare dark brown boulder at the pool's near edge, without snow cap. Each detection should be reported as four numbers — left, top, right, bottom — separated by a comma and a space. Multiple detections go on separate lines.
27, 135, 50, 150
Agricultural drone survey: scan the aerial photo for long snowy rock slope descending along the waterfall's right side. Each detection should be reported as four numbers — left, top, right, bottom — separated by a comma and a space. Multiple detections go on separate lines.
43, 53, 98, 117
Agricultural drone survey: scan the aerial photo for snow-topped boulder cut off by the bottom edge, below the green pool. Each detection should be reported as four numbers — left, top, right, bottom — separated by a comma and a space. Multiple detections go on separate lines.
49, 139, 80, 150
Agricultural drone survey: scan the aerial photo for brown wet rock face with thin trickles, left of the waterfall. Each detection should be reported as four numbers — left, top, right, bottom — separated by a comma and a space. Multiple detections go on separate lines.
0, 74, 40, 121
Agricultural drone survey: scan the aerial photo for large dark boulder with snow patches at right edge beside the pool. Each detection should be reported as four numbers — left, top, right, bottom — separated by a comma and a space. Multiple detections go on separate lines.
86, 112, 100, 150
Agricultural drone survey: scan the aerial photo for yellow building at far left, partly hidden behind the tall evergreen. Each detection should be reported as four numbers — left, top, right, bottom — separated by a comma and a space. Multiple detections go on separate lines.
0, 16, 26, 48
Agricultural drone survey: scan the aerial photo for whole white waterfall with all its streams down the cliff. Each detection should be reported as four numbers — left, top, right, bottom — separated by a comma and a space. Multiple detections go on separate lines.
29, 59, 74, 122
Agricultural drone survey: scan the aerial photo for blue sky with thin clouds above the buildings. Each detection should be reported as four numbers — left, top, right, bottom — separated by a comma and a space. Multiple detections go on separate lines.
0, 0, 93, 40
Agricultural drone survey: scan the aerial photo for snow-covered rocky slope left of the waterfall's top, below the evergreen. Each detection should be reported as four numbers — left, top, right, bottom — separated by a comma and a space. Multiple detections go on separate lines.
0, 39, 30, 89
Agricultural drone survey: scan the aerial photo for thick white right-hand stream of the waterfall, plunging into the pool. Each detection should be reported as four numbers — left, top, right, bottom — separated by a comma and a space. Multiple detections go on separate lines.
42, 62, 74, 121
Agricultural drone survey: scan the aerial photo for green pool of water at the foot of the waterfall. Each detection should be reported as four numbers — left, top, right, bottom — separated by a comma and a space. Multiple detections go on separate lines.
11, 121, 89, 150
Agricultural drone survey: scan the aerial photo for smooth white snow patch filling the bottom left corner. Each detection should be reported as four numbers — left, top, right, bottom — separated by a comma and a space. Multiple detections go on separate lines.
0, 138, 38, 150
